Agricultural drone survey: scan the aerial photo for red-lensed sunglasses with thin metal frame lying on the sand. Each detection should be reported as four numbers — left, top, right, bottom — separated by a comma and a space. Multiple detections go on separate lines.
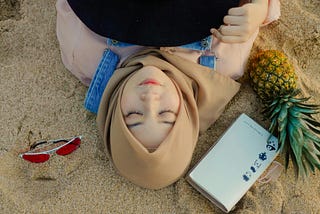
19, 136, 82, 163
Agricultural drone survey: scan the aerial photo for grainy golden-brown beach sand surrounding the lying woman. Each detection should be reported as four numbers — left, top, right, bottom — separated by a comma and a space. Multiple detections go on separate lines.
0, 0, 320, 214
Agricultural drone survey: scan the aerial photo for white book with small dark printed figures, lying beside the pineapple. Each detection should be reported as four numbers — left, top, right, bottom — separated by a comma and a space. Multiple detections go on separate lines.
186, 114, 278, 212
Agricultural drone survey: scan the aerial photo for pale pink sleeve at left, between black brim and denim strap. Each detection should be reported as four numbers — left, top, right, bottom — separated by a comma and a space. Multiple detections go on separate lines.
56, 0, 107, 85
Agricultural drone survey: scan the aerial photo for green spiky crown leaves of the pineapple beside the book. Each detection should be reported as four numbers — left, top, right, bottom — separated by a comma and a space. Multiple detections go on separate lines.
263, 90, 320, 177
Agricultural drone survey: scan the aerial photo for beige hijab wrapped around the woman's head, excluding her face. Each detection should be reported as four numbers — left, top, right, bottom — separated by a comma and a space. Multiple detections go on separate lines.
97, 49, 240, 189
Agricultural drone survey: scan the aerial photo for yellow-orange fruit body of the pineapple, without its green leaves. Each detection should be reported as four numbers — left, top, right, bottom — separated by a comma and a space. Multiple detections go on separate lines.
247, 50, 298, 102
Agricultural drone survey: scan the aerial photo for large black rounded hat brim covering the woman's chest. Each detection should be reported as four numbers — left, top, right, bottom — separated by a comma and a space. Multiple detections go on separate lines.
68, 0, 239, 46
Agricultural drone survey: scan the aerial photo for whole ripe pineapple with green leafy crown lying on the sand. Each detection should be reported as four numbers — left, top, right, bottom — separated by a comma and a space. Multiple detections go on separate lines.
247, 50, 320, 177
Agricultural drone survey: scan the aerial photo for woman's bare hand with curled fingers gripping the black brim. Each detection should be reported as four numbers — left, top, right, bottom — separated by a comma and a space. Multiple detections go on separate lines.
210, 0, 268, 43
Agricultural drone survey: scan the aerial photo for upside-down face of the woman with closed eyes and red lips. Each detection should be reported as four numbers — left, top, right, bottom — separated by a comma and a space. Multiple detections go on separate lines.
121, 66, 180, 150
